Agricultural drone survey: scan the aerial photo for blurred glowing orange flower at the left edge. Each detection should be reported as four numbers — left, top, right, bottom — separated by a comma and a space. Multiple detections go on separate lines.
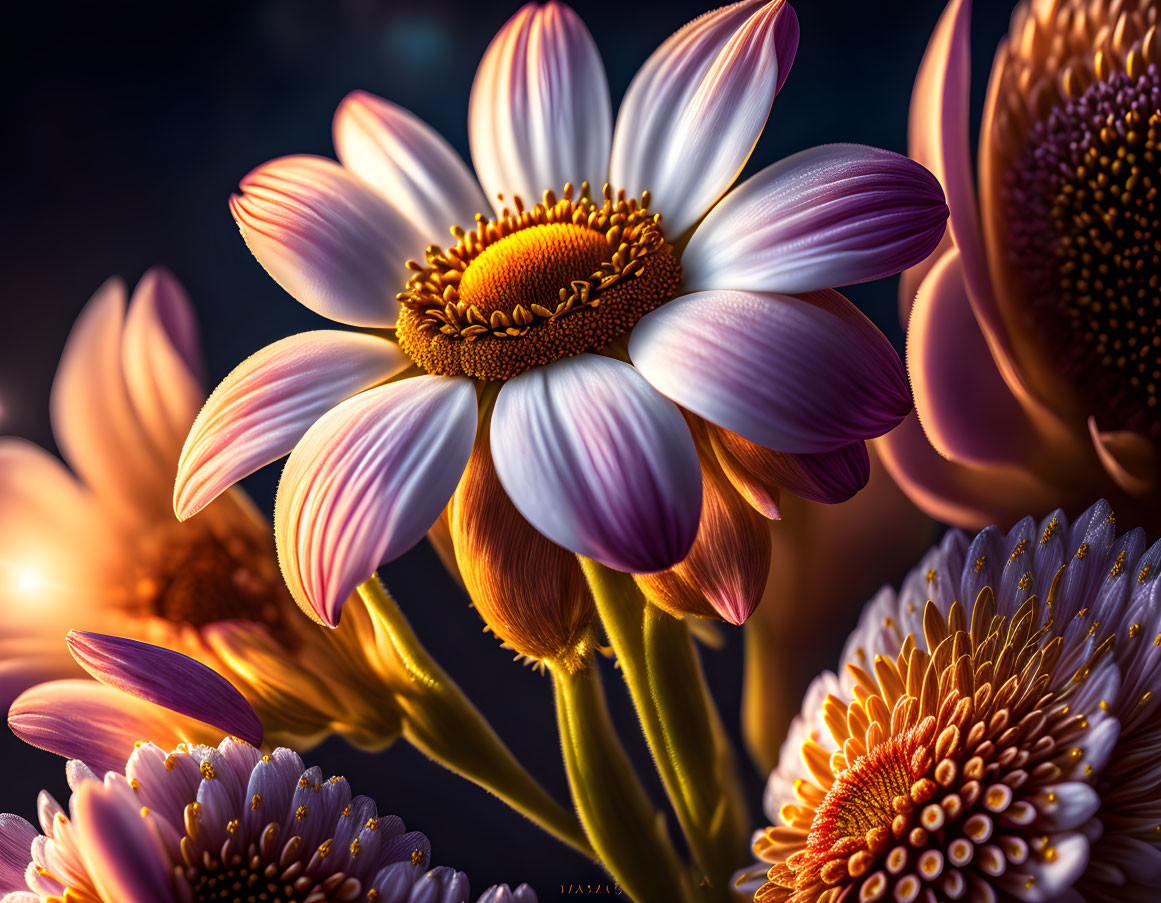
0, 268, 398, 747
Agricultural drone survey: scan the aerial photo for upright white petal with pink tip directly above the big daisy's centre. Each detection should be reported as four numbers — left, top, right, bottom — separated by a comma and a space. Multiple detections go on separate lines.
463, 0, 612, 208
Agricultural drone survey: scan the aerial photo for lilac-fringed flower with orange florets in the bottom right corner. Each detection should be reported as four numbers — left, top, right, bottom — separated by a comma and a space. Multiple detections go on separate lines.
740, 501, 1161, 903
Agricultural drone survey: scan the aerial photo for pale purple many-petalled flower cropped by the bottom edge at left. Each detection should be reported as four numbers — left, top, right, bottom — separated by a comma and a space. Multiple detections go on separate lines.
5, 739, 469, 903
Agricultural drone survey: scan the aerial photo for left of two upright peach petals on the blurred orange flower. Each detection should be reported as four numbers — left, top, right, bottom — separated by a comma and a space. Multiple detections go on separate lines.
50, 279, 172, 520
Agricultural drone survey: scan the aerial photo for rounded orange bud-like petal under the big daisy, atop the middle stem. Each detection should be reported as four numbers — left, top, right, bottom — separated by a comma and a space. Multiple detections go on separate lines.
448, 427, 596, 667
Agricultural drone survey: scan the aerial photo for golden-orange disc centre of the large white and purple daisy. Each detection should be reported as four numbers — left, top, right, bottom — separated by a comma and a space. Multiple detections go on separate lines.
396, 182, 682, 380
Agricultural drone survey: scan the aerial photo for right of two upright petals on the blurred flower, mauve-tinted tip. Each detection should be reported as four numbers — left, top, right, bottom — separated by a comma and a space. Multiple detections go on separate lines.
121, 267, 205, 468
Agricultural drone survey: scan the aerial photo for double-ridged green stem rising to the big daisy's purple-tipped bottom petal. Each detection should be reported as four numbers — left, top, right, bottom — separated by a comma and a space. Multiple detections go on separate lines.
581, 558, 747, 900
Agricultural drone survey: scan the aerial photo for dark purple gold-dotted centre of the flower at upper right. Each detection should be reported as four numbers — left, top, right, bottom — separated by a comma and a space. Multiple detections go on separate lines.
1004, 65, 1161, 436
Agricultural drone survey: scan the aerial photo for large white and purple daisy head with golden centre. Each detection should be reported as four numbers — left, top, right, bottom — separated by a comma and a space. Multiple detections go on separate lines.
174, 0, 947, 626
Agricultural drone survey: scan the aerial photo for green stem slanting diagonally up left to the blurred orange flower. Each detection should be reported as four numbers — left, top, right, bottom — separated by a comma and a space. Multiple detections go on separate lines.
359, 576, 596, 859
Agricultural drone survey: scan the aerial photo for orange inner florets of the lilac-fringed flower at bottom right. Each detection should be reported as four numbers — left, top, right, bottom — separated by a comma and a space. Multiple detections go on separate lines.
755, 580, 1109, 903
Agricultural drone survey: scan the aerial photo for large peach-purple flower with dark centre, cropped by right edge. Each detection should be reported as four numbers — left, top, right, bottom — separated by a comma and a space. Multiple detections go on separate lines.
880, 0, 1161, 528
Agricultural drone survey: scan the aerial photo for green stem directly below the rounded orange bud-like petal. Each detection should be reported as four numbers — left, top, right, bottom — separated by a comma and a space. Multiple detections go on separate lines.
551, 663, 690, 903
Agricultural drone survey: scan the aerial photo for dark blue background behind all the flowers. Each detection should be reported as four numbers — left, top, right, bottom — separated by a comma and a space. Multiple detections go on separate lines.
0, 0, 1010, 901
